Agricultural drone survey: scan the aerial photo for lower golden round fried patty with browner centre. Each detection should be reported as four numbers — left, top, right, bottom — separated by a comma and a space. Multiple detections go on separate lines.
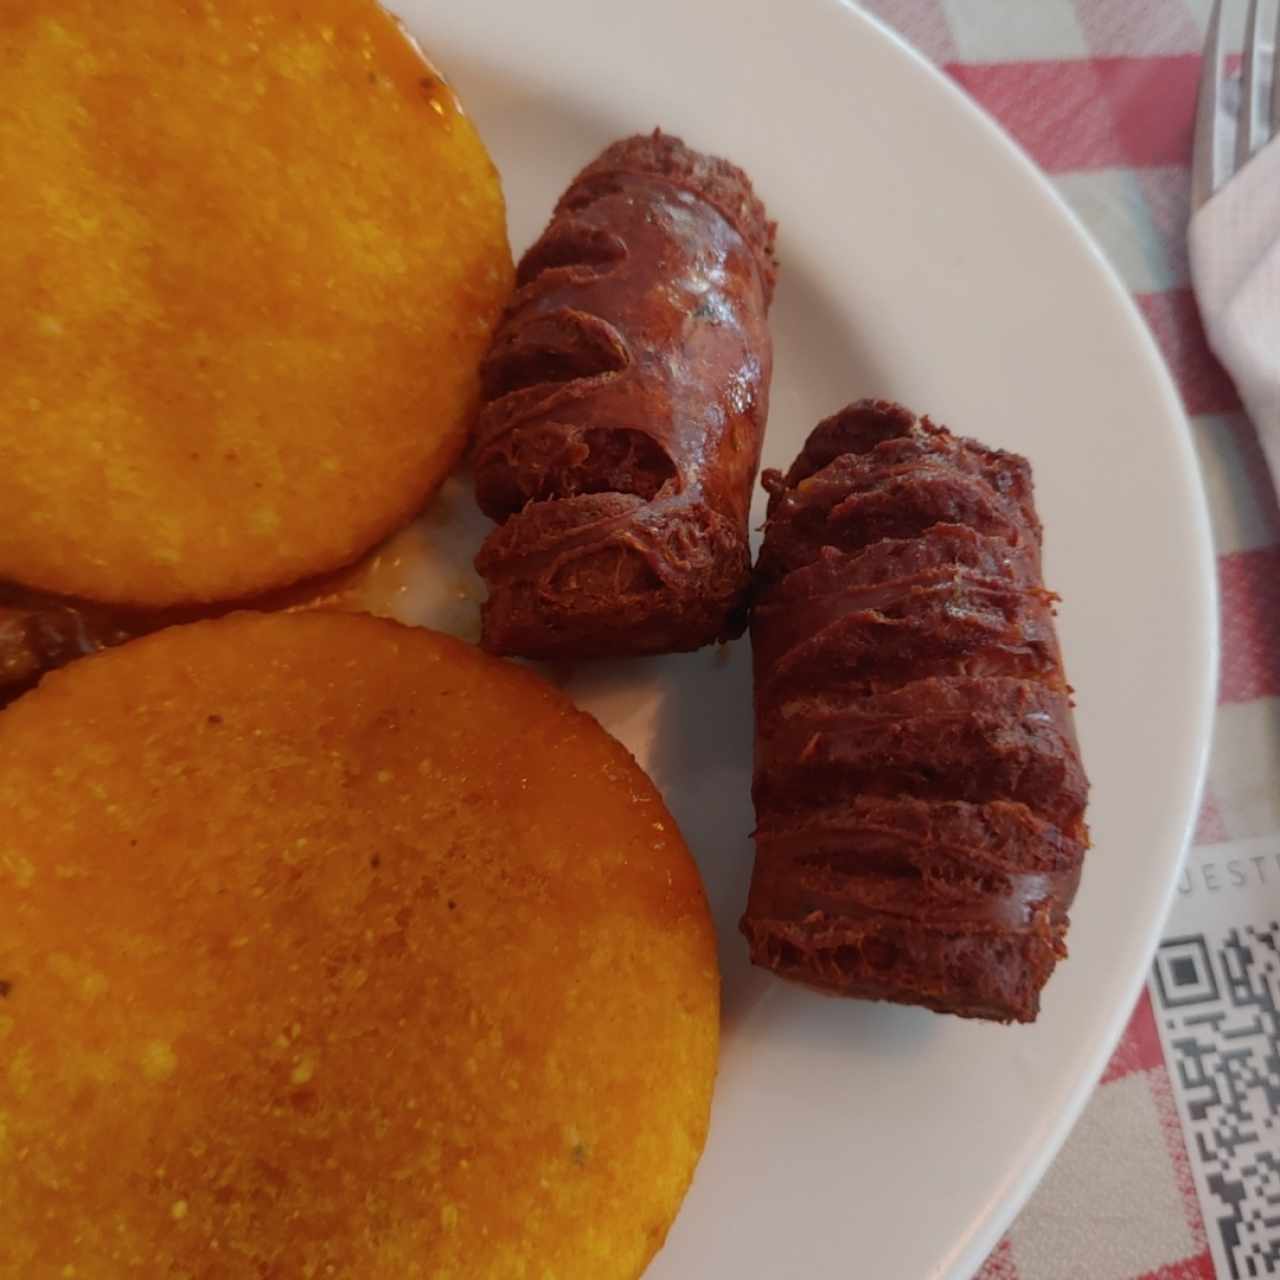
0, 613, 718, 1280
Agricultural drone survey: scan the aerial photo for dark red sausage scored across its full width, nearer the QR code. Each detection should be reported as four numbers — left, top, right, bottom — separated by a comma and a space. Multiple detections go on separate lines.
742, 401, 1089, 1021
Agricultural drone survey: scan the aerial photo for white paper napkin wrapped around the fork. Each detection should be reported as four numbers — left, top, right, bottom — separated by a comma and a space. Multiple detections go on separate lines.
1190, 138, 1280, 485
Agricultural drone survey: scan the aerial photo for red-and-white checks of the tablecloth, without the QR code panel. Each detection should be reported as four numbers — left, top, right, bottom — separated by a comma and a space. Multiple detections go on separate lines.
864, 0, 1280, 1280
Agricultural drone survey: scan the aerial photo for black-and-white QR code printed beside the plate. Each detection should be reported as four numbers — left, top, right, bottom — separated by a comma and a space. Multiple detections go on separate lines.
1155, 923, 1280, 1280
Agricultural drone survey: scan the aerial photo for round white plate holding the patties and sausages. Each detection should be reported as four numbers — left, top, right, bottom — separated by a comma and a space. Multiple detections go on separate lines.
373, 0, 1216, 1280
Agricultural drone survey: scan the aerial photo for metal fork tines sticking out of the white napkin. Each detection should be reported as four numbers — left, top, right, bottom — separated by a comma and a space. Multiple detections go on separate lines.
1192, 0, 1280, 211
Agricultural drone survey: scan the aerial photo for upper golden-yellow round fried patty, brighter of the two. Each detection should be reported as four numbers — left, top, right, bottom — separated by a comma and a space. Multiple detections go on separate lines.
0, 0, 512, 605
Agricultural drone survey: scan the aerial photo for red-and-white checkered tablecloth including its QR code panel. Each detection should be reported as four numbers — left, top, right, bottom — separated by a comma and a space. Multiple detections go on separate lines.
865, 0, 1280, 1280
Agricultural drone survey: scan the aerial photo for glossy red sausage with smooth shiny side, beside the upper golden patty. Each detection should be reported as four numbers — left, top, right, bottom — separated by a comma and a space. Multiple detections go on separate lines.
475, 132, 774, 658
